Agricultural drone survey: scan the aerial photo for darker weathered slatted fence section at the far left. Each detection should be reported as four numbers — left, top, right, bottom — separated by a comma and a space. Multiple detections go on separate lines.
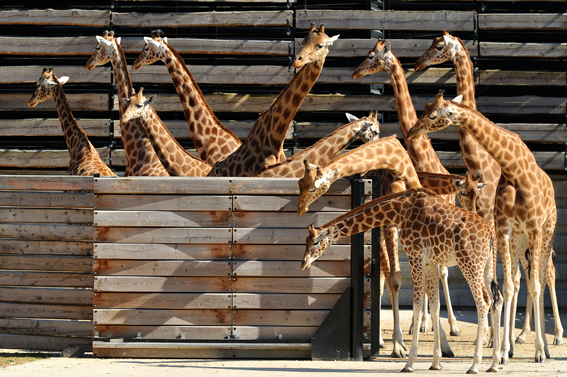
0, 175, 93, 351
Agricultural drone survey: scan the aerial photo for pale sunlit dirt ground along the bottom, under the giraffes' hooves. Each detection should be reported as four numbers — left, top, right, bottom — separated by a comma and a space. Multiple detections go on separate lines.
0, 310, 567, 377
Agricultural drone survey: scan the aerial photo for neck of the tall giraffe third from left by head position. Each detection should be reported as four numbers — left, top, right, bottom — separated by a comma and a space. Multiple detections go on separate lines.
164, 46, 242, 165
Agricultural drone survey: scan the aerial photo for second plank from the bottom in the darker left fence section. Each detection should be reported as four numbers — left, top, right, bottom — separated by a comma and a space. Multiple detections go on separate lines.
0, 318, 93, 338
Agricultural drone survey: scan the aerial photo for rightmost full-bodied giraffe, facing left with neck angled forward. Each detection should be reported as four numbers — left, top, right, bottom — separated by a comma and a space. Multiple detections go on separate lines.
408, 90, 557, 364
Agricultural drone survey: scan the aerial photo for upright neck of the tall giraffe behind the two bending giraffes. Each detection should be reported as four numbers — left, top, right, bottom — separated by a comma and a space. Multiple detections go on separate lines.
386, 59, 447, 173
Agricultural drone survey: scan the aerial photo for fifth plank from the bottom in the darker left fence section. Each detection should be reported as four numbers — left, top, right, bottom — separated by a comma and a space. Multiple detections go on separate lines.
0, 271, 93, 288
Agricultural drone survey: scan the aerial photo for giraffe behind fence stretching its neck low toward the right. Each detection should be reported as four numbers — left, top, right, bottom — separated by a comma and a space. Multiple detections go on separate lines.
252, 112, 380, 178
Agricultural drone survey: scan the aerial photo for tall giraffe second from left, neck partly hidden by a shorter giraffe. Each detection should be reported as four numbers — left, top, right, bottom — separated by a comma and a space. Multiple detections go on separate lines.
85, 31, 169, 177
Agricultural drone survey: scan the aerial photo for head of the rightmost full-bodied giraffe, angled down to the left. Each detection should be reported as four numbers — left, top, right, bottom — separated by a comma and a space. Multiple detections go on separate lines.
406, 89, 463, 140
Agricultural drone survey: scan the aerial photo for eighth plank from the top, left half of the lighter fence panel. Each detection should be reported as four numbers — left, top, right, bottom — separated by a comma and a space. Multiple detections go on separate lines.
93, 292, 232, 309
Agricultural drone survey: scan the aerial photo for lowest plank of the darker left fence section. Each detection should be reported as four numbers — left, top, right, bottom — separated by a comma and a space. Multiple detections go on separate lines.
0, 334, 92, 352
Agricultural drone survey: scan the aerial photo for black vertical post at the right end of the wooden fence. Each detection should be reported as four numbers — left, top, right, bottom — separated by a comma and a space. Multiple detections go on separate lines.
350, 177, 364, 361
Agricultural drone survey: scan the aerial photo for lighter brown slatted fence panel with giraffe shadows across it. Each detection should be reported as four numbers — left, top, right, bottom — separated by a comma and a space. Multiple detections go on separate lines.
93, 178, 370, 356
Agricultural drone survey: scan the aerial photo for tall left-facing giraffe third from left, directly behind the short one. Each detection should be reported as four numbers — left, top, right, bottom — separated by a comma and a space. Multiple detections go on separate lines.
132, 30, 242, 166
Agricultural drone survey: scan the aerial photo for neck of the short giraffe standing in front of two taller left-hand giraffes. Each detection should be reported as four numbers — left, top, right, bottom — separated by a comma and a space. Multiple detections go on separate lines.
138, 108, 210, 177
